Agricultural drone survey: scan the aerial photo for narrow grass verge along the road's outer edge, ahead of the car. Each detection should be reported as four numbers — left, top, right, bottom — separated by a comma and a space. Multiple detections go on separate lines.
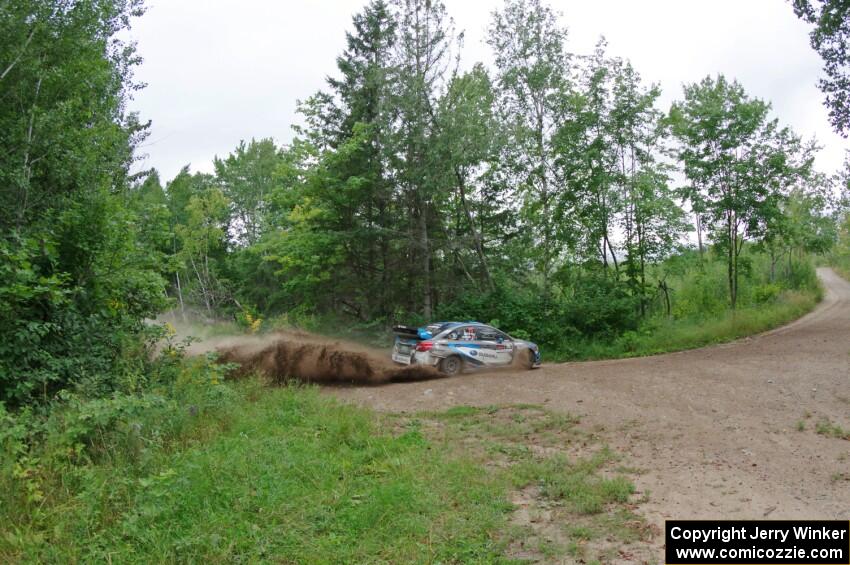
542, 291, 821, 361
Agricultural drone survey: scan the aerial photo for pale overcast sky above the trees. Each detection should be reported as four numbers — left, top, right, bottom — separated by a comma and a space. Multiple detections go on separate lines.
126, 0, 850, 181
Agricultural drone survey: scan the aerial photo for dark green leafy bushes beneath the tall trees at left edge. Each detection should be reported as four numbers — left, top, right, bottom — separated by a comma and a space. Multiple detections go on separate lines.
0, 239, 169, 406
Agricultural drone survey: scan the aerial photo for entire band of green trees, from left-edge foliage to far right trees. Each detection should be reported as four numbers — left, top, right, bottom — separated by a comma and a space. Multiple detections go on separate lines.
0, 0, 837, 405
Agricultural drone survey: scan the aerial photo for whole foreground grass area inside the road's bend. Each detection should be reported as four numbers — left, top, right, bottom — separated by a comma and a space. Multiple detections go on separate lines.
0, 379, 651, 563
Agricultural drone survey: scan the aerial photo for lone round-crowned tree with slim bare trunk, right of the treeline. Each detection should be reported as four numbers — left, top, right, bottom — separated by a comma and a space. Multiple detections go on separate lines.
670, 75, 813, 309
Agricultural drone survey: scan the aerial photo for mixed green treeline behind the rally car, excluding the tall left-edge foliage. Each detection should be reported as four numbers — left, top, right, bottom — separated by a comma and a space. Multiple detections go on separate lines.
137, 0, 835, 328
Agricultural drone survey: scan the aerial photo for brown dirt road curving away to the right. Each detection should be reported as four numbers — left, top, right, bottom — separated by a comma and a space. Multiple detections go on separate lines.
331, 269, 850, 527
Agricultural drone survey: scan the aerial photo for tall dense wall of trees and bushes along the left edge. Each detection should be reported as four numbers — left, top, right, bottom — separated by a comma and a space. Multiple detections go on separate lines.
0, 0, 165, 404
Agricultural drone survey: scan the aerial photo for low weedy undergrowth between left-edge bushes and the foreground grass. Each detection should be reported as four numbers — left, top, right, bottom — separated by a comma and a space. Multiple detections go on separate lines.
0, 342, 237, 515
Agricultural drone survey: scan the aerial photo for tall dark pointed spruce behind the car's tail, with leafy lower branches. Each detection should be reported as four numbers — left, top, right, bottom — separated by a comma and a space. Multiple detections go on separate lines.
263, 0, 400, 319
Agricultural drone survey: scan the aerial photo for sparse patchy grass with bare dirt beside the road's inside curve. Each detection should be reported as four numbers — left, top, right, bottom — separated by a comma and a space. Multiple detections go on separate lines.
402, 405, 655, 562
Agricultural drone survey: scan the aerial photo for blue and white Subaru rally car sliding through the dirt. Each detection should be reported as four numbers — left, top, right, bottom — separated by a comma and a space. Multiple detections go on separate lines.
392, 322, 540, 376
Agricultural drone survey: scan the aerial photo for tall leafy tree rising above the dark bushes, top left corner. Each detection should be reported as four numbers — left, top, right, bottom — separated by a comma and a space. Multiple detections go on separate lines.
0, 0, 144, 231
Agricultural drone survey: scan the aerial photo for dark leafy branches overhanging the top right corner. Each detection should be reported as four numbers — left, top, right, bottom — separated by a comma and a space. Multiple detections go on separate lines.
793, 0, 850, 137
